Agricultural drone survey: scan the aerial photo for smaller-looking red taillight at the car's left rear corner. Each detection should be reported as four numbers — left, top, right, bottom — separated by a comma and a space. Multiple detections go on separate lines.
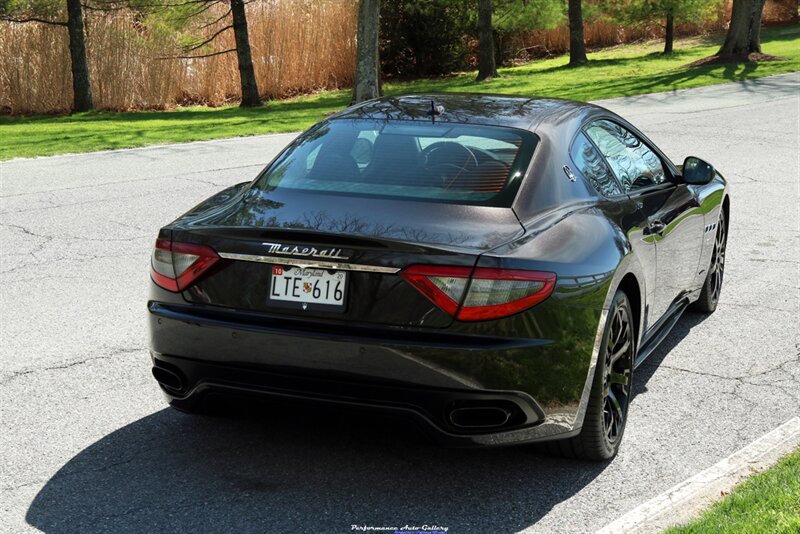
150, 239, 219, 291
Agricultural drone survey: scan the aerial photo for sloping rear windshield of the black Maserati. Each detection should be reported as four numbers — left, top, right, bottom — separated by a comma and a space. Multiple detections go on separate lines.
254, 119, 537, 207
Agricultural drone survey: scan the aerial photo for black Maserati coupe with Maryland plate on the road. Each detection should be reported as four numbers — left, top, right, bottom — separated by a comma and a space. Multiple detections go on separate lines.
147, 94, 730, 460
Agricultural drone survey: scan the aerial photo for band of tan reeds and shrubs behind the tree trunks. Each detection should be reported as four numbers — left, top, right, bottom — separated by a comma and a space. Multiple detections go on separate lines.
0, 0, 797, 114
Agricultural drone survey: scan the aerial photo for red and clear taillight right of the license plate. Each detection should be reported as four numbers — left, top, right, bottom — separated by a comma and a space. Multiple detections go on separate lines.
400, 265, 556, 321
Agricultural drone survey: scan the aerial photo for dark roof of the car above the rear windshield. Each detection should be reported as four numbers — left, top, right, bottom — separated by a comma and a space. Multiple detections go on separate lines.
330, 93, 601, 130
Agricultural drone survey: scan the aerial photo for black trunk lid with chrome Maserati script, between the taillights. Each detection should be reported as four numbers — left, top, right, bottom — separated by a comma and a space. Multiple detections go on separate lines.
172, 191, 524, 328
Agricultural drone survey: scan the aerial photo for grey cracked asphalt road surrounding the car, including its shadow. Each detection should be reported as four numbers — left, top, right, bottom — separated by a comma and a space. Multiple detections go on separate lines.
0, 74, 800, 532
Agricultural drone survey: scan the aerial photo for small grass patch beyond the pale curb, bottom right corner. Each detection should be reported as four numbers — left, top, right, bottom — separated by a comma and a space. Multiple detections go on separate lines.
665, 450, 800, 534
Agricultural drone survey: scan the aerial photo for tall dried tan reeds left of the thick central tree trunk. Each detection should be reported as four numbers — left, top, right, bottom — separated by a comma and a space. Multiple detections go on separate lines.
0, 0, 356, 113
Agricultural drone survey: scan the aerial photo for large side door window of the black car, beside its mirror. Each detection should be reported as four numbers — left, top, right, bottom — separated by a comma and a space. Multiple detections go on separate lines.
586, 120, 666, 193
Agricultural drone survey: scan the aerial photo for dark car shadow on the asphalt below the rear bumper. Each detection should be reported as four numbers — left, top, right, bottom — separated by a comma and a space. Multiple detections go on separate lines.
26, 396, 610, 533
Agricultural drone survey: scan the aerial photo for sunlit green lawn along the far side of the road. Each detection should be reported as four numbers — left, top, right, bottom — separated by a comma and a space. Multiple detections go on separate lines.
0, 26, 800, 160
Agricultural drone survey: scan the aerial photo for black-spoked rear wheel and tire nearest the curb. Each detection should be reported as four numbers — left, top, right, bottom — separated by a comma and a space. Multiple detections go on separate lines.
548, 291, 636, 461
